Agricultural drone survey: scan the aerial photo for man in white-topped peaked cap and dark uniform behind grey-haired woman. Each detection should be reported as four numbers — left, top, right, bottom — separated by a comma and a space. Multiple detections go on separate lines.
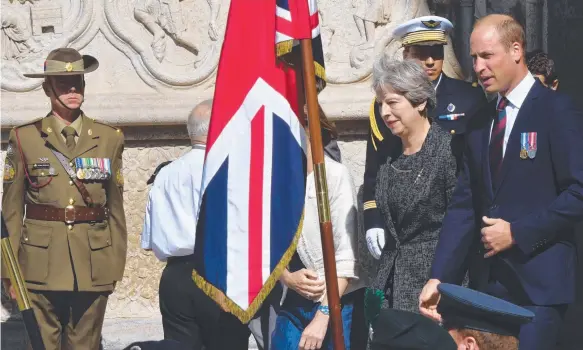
363, 16, 487, 259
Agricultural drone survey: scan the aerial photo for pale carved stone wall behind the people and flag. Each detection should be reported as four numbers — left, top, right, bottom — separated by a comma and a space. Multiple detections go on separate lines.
0, 0, 460, 317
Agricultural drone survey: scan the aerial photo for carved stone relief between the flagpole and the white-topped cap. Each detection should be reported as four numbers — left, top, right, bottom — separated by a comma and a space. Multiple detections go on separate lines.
319, 0, 462, 84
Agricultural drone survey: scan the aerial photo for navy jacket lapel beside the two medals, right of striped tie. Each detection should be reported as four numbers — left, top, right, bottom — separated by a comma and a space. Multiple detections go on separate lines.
494, 83, 544, 198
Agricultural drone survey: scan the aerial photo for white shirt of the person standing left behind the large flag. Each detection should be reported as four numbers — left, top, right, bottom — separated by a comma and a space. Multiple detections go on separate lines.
141, 145, 205, 261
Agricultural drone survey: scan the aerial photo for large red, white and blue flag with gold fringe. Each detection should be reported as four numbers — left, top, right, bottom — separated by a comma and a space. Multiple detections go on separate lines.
193, 0, 324, 323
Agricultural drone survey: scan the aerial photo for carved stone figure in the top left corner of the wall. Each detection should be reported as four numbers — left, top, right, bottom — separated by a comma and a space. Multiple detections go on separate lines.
1, 1, 41, 61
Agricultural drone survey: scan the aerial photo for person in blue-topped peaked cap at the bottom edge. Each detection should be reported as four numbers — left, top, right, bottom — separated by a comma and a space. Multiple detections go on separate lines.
437, 283, 534, 350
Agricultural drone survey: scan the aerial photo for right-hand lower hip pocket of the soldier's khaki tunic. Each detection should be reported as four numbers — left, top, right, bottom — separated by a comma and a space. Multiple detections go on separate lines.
87, 223, 115, 286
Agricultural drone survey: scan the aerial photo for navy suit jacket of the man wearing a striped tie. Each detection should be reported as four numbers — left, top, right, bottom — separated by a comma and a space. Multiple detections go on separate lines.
431, 81, 583, 305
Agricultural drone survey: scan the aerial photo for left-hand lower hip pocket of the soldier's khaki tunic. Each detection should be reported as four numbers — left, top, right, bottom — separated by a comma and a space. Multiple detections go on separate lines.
18, 221, 53, 283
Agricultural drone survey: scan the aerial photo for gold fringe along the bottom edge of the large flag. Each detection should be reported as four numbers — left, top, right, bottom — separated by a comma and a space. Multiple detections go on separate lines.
192, 212, 304, 324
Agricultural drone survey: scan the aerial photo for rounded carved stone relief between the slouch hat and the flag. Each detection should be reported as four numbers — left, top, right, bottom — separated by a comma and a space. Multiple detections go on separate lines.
105, 0, 228, 87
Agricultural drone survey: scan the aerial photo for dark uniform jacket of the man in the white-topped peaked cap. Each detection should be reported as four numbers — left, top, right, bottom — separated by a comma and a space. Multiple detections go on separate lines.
363, 74, 487, 230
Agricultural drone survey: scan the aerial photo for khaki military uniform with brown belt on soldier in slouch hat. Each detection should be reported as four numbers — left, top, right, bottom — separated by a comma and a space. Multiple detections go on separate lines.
2, 114, 127, 349
